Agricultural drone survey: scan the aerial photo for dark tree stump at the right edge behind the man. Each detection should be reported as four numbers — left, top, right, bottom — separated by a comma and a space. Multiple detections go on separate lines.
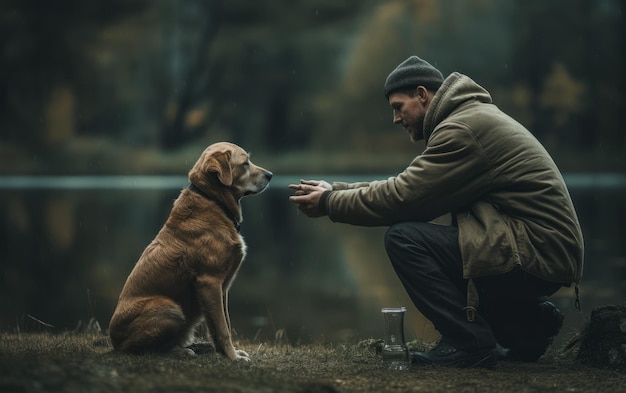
578, 304, 626, 370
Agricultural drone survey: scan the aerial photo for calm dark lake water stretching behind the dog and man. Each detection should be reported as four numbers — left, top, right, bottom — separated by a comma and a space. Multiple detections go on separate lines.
0, 174, 626, 343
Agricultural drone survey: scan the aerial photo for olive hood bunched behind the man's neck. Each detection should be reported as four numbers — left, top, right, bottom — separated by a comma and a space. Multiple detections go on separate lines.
424, 72, 492, 143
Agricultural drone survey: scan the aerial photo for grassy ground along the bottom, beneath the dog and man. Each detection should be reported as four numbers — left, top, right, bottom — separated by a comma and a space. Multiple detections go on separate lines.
0, 333, 626, 393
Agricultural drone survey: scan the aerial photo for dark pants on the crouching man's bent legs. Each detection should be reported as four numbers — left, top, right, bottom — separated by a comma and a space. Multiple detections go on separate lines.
385, 222, 560, 350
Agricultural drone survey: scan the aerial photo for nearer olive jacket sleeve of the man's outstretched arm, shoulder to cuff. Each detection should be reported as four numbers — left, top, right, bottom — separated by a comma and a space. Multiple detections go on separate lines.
326, 123, 492, 226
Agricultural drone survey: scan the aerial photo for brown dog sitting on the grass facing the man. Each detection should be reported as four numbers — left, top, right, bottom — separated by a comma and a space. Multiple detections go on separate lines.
109, 142, 272, 360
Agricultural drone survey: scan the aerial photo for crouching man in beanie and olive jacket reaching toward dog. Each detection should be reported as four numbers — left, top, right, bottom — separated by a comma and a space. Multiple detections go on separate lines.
289, 56, 583, 368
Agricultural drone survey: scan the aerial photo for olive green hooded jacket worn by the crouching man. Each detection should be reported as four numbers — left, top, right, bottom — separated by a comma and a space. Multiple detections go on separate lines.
324, 73, 583, 285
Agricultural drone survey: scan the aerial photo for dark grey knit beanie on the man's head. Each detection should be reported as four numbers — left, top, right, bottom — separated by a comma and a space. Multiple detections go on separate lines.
385, 56, 443, 98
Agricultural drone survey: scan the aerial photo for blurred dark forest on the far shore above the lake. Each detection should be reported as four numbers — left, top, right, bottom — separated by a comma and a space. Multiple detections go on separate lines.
0, 0, 626, 174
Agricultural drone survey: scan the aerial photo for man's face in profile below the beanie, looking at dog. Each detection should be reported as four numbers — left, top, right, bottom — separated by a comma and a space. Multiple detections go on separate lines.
389, 88, 428, 142
